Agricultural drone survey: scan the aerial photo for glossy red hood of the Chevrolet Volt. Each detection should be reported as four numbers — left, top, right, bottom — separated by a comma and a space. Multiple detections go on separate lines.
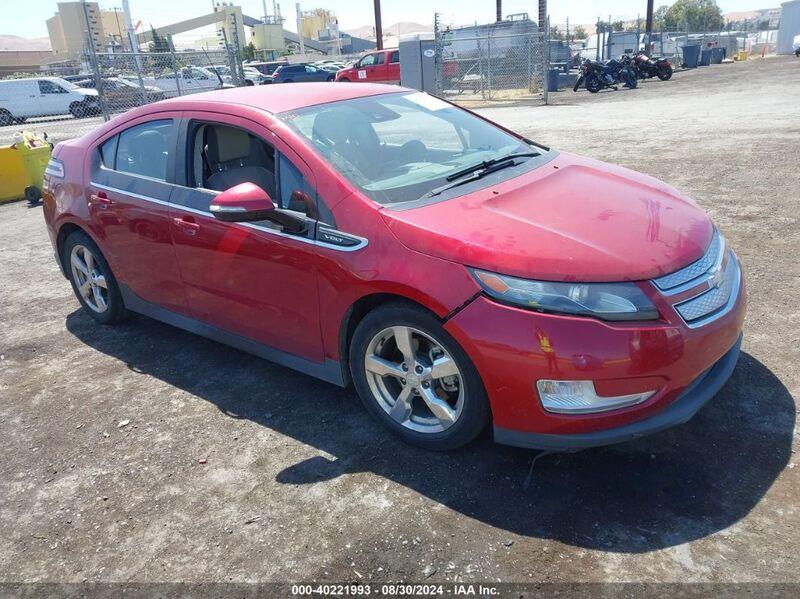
381, 153, 713, 282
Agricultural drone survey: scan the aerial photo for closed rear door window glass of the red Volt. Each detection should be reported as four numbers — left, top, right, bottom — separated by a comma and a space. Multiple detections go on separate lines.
113, 119, 174, 181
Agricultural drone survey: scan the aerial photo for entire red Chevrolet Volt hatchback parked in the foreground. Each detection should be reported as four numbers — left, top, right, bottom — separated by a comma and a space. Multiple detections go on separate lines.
44, 83, 745, 451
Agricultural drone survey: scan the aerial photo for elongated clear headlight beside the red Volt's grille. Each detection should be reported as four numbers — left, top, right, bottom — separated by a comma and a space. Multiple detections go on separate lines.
470, 269, 658, 320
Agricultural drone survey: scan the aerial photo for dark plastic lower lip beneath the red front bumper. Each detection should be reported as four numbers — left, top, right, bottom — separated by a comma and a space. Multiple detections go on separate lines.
494, 335, 742, 451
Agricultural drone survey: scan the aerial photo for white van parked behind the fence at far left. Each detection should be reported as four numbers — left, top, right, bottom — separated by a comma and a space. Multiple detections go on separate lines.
0, 77, 100, 126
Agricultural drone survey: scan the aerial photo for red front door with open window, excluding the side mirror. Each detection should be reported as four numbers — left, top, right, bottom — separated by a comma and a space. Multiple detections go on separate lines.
171, 112, 323, 362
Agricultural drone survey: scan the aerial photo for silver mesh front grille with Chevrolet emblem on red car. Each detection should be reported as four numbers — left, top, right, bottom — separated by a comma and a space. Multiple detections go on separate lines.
653, 231, 741, 328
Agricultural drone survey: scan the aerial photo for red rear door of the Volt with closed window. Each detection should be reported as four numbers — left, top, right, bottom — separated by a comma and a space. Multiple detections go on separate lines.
88, 112, 186, 313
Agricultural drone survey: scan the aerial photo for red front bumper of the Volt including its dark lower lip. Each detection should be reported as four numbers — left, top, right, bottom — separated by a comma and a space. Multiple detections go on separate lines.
445, 262, 746, 449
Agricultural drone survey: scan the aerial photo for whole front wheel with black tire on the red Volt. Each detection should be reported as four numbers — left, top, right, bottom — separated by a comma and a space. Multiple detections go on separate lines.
349, 302, 489, 451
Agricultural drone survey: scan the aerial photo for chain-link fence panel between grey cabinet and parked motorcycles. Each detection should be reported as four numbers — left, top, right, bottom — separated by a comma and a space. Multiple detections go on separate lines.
435, 27, 549, 105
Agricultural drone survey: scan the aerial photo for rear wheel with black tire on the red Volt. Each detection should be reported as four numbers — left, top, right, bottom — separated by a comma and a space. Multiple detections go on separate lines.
61, 231, 127, 324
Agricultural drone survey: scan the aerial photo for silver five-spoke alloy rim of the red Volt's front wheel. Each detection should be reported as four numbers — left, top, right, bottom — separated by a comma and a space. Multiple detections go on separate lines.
364, 326, 465, 433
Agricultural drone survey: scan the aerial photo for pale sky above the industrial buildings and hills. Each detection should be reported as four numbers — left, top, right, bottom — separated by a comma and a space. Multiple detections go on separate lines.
10, 0, 782, 37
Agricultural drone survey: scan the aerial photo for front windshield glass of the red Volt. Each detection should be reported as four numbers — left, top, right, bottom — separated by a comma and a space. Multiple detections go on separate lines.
280, 92, 531, 204
